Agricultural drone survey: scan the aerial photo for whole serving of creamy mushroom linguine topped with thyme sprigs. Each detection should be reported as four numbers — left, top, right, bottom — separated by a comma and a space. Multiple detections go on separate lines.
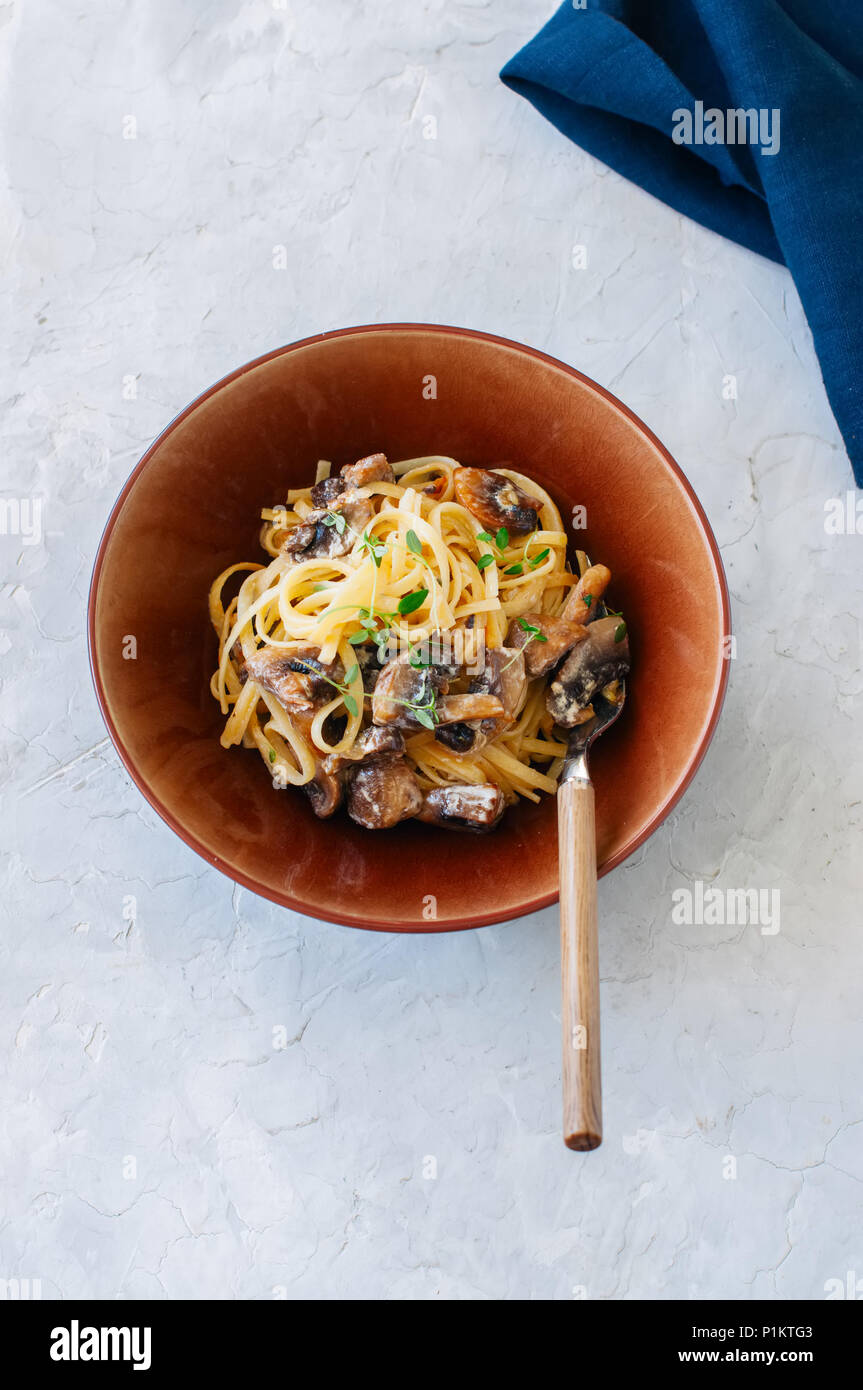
210, 453, 630, 831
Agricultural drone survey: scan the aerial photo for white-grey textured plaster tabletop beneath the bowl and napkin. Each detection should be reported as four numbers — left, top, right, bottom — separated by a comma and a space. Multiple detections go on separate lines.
0, 0, 863, 1298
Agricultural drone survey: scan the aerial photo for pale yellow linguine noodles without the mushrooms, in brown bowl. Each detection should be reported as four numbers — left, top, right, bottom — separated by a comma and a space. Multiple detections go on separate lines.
210, 455, 625, 823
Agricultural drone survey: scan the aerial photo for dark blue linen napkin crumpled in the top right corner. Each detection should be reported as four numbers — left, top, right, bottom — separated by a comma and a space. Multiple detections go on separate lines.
500, 0, 863, 487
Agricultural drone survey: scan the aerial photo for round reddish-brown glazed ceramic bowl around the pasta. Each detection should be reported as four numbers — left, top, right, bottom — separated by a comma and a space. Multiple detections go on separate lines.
89, 324, 728, 931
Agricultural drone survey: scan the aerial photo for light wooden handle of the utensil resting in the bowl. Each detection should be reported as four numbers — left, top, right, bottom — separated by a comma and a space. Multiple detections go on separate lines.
557, 777, 602, 1150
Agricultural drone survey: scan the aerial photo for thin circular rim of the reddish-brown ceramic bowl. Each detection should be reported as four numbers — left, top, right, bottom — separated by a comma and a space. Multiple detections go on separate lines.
86, 321, 731, 935
